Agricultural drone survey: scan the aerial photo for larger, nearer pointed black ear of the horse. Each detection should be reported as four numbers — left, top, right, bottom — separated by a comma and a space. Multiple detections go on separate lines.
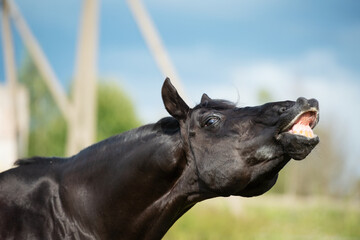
161, 78, 190, 120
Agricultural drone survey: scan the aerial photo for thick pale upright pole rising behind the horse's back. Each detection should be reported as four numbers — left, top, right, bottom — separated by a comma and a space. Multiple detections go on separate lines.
66, 0, 99, 155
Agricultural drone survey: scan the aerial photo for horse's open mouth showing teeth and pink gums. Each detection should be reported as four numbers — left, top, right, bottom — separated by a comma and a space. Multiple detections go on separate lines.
282, 109, 318, 138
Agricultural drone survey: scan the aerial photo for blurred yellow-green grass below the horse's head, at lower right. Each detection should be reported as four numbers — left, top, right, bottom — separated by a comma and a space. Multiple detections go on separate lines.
164, 196, 360, 240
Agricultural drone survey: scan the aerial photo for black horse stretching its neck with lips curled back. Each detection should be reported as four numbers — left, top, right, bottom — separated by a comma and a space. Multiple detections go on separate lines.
0, 79, 319, 240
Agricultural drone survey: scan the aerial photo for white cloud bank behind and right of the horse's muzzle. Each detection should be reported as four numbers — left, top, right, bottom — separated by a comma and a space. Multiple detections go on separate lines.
222, 51, 360, 176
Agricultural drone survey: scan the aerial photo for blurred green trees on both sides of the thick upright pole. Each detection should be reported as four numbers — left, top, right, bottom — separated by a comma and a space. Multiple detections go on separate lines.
19, 57, 140, 156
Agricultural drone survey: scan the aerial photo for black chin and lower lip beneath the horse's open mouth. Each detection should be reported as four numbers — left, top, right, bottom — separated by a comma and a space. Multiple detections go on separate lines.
277, 132, 320, 160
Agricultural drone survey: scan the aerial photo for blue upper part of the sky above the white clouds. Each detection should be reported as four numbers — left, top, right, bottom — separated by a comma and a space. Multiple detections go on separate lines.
0, 0, 360, 89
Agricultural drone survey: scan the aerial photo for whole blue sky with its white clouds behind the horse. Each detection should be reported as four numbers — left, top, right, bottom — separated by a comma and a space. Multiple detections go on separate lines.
0, 0, 360, 176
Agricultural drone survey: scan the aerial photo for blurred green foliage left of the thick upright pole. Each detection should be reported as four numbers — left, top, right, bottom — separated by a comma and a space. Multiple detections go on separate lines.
19, 57, 66, 156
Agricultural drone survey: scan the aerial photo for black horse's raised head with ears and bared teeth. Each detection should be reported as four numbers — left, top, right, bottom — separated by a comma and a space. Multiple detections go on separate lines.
162, 79, 319, 197
